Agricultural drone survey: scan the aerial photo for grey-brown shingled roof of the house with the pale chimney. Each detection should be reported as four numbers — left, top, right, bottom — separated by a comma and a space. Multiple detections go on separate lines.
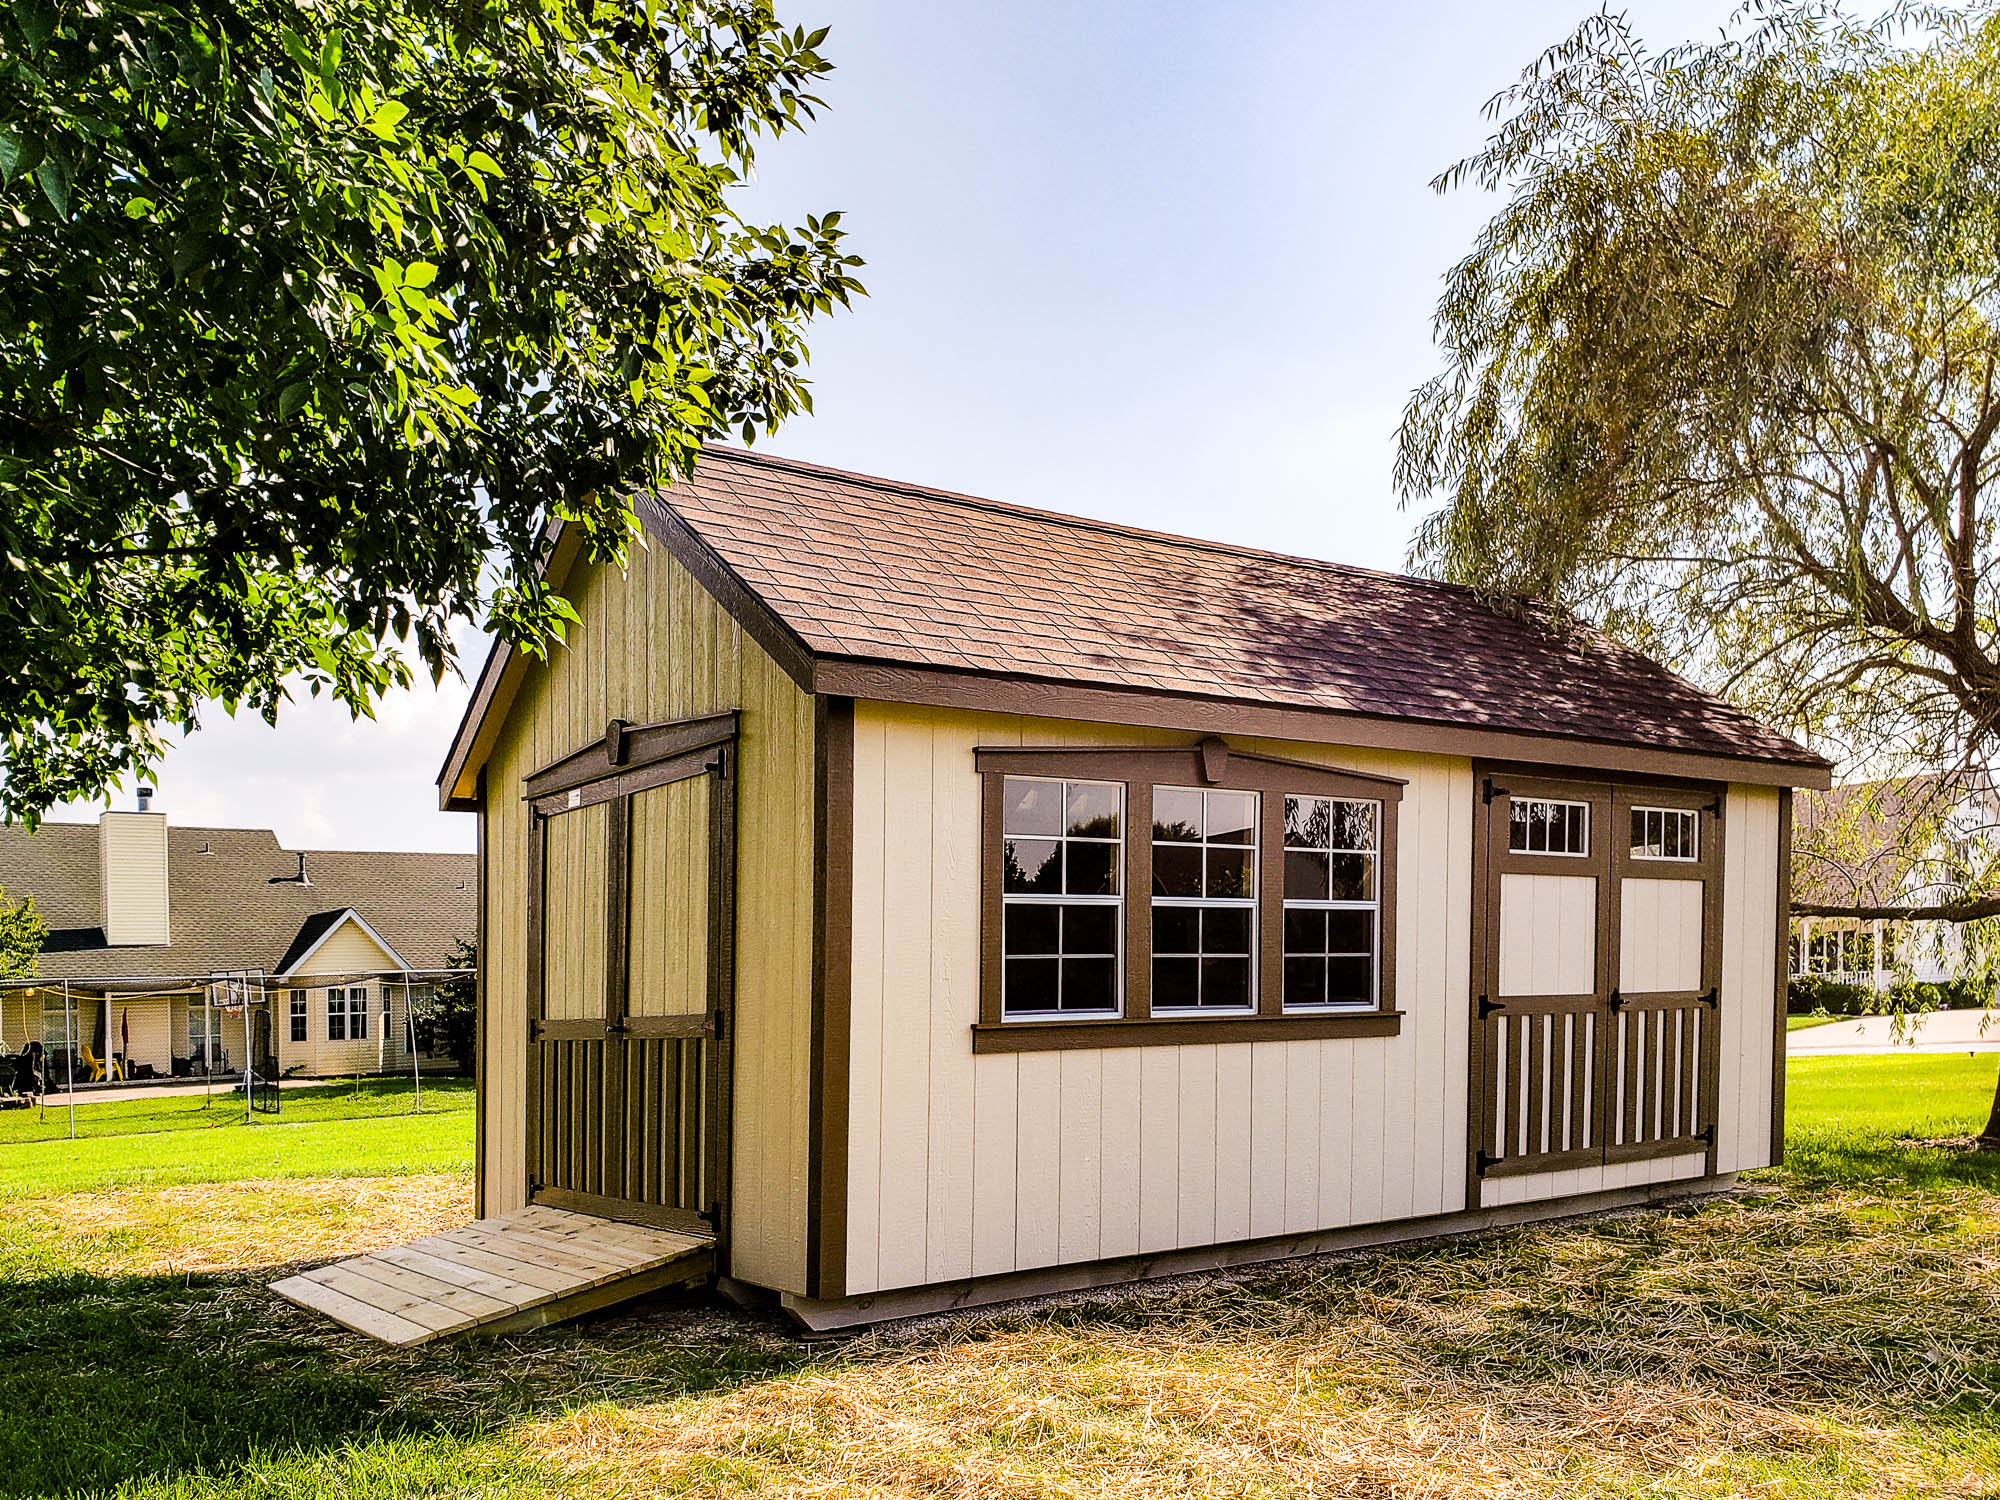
0, 822, 478, 980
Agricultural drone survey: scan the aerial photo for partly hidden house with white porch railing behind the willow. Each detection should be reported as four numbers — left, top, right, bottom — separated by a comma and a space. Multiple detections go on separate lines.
1790, 774, 2000, 990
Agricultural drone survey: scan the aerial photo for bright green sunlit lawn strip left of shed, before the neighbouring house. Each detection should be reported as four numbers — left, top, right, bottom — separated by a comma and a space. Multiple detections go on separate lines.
0, 1078, 474, 1200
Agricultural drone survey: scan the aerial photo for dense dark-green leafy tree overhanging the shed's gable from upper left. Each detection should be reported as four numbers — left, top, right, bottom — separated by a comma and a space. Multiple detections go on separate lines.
0, 0, 860, 822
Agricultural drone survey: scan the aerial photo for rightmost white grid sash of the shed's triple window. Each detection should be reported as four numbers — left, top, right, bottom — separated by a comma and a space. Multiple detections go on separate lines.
1284, 796, 1382, 1010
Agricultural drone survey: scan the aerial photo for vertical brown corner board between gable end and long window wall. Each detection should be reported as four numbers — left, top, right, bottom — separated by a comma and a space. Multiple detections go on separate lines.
806, 696, 854, 1298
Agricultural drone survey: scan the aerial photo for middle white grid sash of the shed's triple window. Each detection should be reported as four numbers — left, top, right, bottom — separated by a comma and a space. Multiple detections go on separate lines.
1152, 786, 1258, 1016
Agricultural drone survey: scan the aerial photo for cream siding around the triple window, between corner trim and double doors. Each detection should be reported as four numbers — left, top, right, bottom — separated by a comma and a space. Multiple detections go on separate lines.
846, 702, 1472, 1294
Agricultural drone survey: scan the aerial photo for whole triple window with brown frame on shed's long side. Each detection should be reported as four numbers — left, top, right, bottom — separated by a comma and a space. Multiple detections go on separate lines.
972, 740, 1402, 1052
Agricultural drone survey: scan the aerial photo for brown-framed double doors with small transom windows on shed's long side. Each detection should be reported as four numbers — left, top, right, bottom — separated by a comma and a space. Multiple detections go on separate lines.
1470, 770, 1722, 1204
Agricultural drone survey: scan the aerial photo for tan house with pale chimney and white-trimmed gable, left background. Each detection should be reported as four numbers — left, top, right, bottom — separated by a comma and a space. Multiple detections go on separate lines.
0, 794, 478, 1082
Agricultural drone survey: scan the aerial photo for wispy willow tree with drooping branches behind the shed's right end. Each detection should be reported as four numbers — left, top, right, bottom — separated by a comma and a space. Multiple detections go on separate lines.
1396, 4, 2000, 1146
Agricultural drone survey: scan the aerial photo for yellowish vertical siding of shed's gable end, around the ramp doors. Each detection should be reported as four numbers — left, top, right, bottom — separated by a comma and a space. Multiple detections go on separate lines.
482, 542, 814, 1292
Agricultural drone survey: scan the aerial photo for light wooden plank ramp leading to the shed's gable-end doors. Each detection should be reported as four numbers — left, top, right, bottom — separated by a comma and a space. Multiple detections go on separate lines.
270, 1206, 714, 1346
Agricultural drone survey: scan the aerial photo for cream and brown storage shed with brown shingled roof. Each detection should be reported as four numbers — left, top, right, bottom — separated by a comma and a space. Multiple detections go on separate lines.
440, 450, 1828, 1328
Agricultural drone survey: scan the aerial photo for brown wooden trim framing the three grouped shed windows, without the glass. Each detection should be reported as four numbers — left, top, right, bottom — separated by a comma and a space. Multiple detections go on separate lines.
972, 738, 1406, 1052
